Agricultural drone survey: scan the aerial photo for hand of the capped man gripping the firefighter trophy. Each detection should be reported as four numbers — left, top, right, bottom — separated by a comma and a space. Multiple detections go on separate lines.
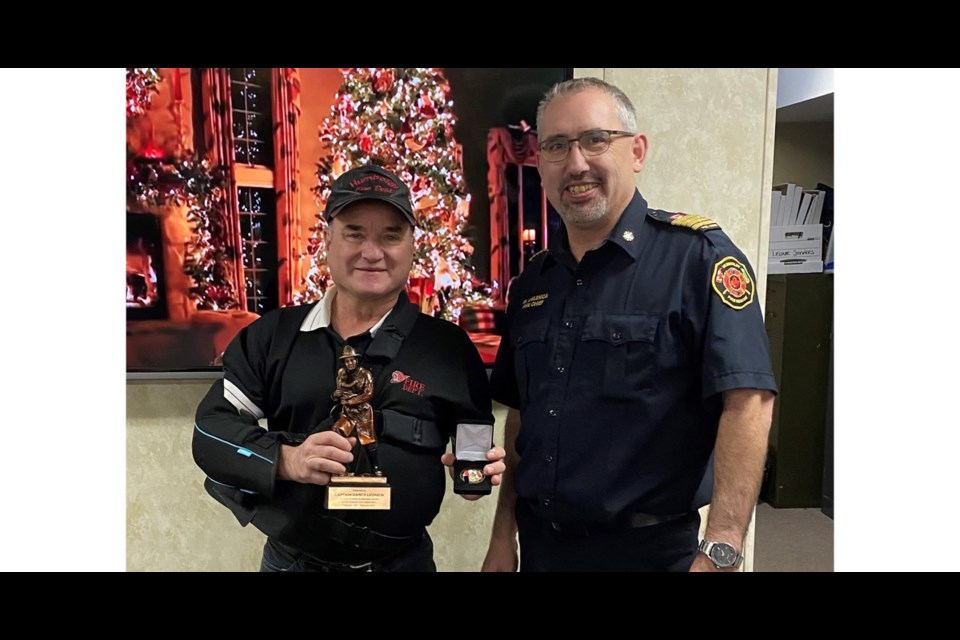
277, 431, 357, 485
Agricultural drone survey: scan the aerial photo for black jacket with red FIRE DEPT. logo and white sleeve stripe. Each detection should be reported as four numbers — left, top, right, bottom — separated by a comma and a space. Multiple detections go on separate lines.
193, 294, 493, 562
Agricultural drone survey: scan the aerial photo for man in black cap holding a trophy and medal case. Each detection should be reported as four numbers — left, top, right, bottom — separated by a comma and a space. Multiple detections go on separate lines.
193, 165, 505, 572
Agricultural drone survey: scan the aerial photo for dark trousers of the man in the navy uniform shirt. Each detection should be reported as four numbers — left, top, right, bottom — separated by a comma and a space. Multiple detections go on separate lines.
516, 499, 700, 572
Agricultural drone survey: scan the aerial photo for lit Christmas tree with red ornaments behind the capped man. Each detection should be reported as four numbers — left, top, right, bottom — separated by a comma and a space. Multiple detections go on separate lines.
296, 68, 490, 322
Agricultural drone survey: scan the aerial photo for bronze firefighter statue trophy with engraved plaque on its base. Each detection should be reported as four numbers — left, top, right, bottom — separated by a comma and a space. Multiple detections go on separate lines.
324, 345, 390, 510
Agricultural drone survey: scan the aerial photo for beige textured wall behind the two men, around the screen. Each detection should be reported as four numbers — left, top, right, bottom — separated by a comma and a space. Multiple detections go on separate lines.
127, 69, 776, 571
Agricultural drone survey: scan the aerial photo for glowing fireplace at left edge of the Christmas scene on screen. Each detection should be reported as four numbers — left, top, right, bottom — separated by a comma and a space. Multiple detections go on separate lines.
127, 211, 167, 320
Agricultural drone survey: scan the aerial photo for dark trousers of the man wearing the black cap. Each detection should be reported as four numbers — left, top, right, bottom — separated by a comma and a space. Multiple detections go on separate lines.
260, 532, 437, 573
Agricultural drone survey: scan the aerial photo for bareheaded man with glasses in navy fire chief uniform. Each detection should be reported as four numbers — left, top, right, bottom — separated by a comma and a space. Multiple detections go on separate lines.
484, 78, 776, 571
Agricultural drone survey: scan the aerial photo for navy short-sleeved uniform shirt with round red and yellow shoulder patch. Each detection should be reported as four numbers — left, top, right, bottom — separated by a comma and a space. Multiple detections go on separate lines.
491, 192, 776, 522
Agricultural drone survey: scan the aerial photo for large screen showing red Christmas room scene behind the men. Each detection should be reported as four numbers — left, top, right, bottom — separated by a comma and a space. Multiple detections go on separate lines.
126, 68, 572, 374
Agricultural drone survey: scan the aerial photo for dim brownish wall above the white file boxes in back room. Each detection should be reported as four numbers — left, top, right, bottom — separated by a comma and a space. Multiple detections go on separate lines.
773, 122, 834, 189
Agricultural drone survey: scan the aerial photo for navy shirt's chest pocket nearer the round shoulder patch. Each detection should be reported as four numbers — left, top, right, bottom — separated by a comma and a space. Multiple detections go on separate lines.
580, 312, 660, 400
